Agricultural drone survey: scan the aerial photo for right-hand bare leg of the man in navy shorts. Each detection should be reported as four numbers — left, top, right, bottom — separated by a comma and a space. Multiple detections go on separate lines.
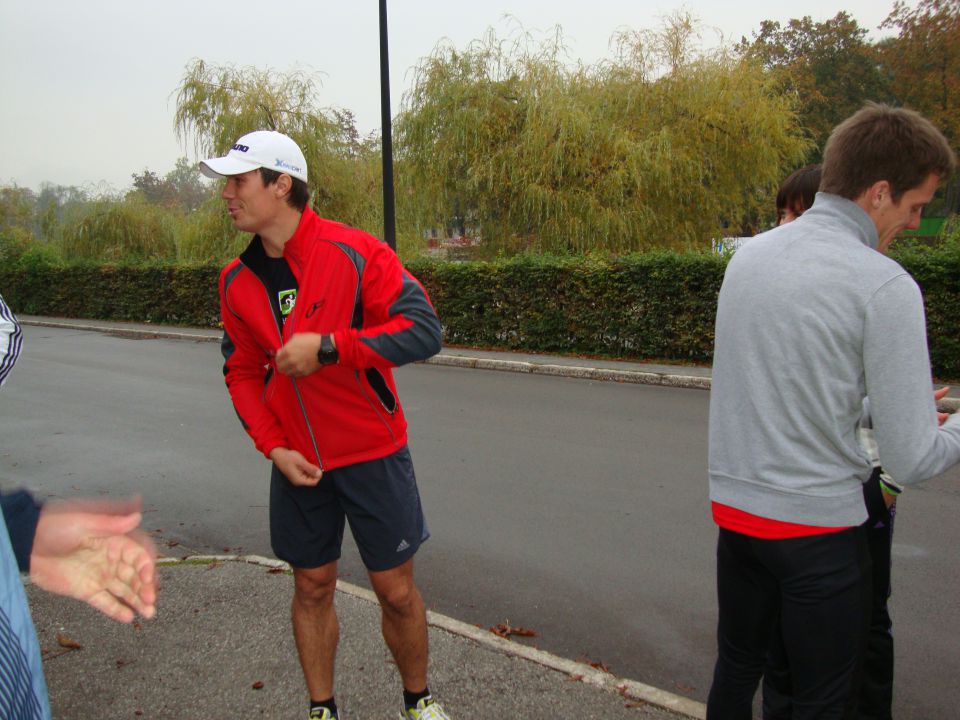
369, 559, 427, 692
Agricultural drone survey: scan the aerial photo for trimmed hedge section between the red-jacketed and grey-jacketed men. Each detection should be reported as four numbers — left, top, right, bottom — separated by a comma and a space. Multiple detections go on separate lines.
409, 252, 726, 362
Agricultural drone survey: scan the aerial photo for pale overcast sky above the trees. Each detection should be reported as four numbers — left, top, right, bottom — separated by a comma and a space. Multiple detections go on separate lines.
0, 0, 900, 190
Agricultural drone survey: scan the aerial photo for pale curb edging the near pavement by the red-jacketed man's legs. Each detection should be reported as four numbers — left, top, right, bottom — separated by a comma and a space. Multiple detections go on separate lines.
157, 555, 707, 720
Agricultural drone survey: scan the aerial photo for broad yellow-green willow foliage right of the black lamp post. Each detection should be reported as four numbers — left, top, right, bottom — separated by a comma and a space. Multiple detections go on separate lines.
396, 16, 806, 252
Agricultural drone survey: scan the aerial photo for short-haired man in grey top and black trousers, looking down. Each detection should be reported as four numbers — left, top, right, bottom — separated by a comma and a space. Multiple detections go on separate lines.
707, 105, 960, 720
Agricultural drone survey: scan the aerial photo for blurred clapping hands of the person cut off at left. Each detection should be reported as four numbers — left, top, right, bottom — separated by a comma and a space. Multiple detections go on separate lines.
30, 498, 157, 622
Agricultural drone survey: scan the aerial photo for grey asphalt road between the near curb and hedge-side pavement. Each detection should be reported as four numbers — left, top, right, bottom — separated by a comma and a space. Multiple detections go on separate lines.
0, 327, 960, 720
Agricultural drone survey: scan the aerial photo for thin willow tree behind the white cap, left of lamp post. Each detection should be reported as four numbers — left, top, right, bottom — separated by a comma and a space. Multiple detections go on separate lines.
174, 60, 383, 242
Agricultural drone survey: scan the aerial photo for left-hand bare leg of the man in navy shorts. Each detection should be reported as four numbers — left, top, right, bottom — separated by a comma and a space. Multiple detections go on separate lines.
291, 562, 340, 700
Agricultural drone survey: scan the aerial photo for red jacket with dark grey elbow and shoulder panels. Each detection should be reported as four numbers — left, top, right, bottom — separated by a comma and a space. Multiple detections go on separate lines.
220, 208, 440, 470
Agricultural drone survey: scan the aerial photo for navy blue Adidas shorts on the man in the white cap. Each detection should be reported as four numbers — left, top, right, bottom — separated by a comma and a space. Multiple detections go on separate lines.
270, 447, 430, 572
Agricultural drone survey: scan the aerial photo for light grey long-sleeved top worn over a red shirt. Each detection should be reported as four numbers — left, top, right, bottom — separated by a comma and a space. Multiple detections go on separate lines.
709, 193, 960, 527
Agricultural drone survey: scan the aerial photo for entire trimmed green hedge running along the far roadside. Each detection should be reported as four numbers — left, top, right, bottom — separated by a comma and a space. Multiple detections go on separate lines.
0, 245, 960, 379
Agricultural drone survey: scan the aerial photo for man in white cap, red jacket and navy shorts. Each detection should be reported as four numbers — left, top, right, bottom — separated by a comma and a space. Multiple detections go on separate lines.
200, 130, 448, 720
